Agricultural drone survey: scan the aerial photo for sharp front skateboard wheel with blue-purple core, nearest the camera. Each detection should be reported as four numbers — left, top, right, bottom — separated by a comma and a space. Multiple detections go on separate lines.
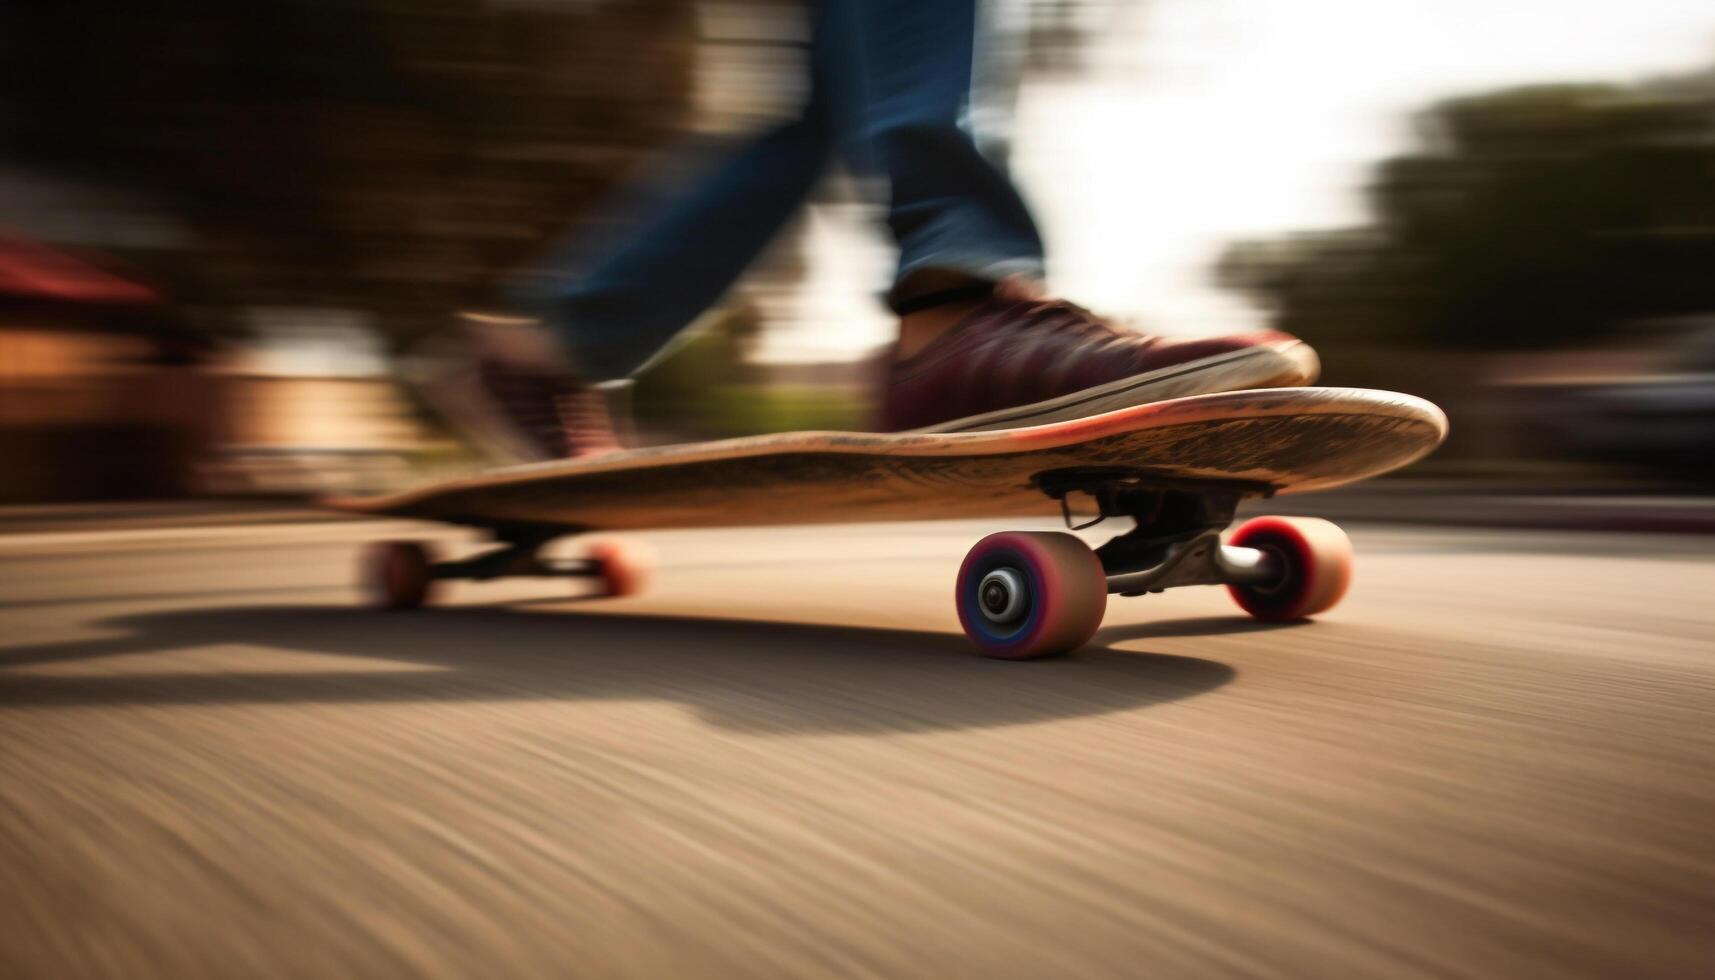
955, 530, 1108, 661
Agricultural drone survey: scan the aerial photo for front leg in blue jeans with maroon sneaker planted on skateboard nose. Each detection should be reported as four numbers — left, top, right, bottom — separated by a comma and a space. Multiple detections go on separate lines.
825, 0, 1315, 431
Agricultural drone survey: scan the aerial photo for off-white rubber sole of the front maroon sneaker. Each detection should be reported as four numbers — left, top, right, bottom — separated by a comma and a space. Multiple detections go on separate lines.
907, 340, 1322, 433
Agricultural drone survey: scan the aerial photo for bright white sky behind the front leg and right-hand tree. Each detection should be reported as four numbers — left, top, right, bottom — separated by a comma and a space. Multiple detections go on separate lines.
768, 0, 1715, 359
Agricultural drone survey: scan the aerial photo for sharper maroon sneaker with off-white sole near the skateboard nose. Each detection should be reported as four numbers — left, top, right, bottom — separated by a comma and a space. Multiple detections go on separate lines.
880, 283, 1321, 433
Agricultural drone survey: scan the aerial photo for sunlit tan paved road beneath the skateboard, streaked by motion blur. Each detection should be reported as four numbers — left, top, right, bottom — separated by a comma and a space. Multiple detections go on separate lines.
0, 523, 1715, 978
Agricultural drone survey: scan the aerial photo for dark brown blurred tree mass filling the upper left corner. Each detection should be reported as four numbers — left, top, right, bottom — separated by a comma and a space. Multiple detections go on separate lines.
0, 0, 695, 342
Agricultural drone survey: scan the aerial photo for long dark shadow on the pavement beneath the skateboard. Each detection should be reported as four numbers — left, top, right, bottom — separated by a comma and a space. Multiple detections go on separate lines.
0, 606, 1235, 735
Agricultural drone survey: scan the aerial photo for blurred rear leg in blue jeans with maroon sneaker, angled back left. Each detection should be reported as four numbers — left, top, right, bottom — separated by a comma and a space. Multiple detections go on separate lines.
429, 15, 851, 458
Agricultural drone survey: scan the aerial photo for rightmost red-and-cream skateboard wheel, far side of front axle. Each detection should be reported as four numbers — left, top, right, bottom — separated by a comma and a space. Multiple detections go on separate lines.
1226, 517, 1351, 621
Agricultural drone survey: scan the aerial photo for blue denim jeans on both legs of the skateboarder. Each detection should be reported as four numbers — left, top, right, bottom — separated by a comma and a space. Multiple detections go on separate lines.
525, 0, 1043, 381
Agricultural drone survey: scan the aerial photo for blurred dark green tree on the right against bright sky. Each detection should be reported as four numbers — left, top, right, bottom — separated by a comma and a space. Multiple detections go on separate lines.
1216, 76, 1715, 348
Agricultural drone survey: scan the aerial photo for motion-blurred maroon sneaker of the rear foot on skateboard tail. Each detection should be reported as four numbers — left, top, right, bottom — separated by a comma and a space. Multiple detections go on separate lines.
425, 318, 621, 462
